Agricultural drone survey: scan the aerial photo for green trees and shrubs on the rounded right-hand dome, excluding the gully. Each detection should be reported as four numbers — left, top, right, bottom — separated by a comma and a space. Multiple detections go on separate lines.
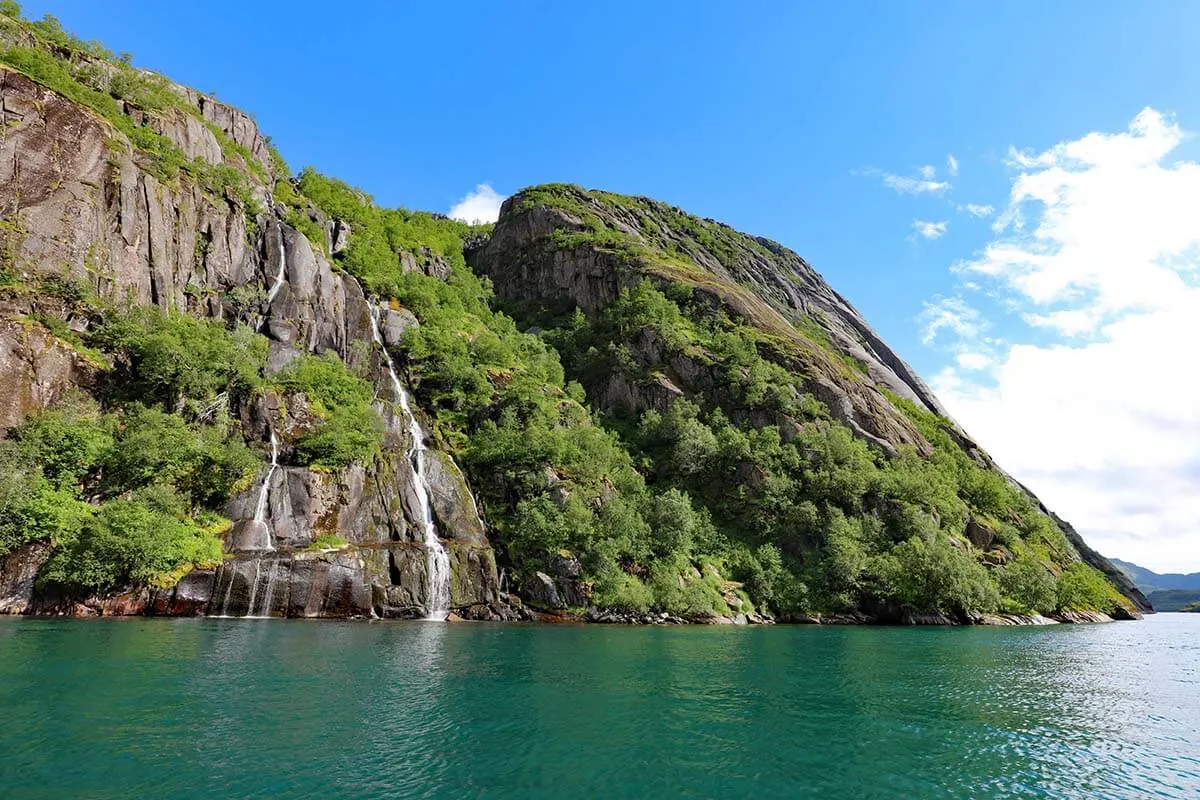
484, 185, 1123, 615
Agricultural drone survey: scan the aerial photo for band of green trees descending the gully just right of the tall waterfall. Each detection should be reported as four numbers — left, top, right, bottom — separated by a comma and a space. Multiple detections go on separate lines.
292, 170, 748, 612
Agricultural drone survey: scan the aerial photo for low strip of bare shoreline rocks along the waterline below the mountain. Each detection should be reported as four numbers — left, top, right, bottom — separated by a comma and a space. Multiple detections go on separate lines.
0, 543, 1141, 626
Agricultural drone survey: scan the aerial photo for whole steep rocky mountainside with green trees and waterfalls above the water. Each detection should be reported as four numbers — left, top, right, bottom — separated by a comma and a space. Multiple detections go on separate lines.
0, 10, 1150, 624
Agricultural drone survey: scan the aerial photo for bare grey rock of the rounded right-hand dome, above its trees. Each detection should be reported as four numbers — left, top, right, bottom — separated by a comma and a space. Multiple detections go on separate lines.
469, 185, 1150, 610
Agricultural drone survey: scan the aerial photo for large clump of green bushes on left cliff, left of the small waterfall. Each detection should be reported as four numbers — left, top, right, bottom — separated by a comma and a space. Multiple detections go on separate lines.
0, 303, 266, 590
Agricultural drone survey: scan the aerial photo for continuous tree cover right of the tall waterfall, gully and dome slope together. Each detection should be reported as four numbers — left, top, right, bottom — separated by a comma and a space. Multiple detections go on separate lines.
285, 170, 1118, 615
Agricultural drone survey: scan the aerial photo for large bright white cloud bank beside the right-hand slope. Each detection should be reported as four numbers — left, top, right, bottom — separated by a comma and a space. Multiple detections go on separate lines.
922, 108, 1200, 571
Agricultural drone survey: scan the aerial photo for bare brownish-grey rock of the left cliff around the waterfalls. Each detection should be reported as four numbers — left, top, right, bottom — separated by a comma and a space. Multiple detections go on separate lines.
0, 67, 497, 616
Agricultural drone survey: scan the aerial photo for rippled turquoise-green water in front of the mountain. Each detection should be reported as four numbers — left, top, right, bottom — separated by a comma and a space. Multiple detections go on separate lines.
0, 614, 1200, 800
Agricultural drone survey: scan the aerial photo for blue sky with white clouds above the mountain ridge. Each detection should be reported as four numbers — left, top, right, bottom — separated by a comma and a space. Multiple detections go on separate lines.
23, 0, 1200, 570
